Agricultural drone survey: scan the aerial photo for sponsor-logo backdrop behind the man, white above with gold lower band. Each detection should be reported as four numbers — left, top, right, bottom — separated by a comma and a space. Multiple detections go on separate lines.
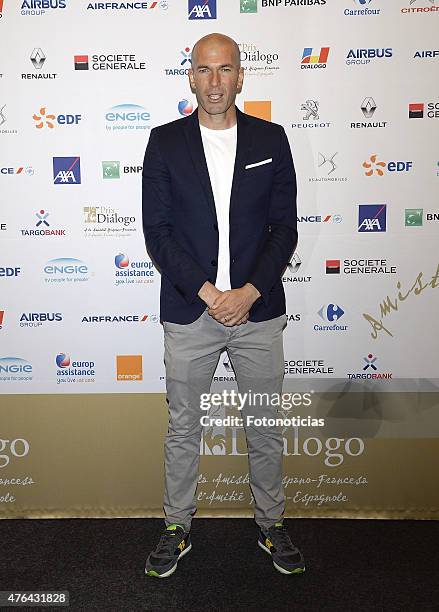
0, 0, 439, 518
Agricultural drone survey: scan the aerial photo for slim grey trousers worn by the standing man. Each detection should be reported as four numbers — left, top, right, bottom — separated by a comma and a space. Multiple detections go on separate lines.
163, 309, 286, 531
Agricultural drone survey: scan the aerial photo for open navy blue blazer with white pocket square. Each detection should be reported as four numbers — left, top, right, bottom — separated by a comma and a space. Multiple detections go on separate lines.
142, 109, 297, 324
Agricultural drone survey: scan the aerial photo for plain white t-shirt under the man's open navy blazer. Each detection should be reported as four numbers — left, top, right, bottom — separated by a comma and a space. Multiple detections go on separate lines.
200, 125, 237, 291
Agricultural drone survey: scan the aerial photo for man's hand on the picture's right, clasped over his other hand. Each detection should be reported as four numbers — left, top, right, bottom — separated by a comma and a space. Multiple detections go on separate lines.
208, 283, 261, 327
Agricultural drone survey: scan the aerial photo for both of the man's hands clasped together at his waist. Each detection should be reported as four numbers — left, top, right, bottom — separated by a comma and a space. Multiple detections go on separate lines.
198, 281, 261, 327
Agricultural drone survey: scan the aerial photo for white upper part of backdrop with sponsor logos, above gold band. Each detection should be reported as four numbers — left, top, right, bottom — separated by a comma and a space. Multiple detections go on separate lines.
0, 0, 439, 393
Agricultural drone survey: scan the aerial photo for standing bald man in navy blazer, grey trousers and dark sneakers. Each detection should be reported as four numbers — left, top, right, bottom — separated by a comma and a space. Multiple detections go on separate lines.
143, 34, 305, 578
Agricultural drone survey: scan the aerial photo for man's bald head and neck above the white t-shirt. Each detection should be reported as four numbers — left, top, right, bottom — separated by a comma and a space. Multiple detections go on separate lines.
189, 34, 244, 127
